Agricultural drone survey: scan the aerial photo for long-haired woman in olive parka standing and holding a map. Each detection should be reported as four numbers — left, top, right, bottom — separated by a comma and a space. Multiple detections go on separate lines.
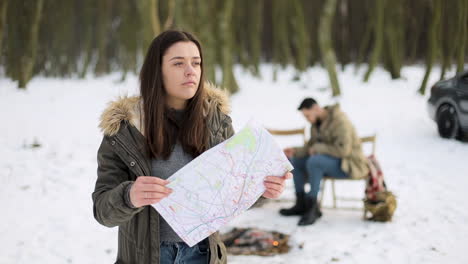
93, 31, 292, 263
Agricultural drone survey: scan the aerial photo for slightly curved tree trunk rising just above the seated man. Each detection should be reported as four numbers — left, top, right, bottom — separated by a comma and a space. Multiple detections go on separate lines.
319, 0, 341, 96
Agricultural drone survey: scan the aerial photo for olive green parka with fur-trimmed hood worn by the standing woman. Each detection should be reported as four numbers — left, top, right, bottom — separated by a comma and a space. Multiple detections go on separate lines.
92, 84, 234, 264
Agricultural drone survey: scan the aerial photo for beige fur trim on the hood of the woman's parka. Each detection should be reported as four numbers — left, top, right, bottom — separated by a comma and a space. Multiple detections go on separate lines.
99, 82, 231, 136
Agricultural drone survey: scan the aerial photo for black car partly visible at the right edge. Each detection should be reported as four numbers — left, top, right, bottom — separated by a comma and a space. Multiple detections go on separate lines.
427, 71, 468, 138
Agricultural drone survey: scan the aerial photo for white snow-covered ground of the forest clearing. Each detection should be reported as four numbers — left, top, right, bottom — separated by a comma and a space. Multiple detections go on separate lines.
0, 65, 468, 264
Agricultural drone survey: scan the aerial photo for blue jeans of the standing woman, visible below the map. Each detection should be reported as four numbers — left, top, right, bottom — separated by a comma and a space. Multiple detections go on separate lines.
159, 239, 210, 264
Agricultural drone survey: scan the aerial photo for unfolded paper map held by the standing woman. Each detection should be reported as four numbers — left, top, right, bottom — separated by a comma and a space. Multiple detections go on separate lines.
153, 121, 293, 247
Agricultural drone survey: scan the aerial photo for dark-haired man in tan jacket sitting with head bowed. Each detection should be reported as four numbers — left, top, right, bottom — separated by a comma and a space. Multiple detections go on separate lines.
280, 98, 368, 225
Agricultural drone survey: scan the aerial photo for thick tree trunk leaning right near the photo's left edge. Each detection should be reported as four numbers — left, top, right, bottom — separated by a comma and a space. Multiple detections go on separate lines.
18, 0, 44, 89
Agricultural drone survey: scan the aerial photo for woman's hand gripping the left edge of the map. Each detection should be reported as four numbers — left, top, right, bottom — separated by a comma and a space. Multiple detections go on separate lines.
130, 176, 172, 207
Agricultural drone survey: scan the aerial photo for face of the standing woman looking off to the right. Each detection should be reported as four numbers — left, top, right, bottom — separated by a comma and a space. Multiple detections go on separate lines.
162, 41, 201, 109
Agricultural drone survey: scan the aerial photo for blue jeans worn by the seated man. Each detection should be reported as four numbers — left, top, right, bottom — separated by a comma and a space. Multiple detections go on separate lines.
291, 154, 349, 198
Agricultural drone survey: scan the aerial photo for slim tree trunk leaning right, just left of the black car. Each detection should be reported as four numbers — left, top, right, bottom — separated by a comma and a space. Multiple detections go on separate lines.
418, 0, 442, 94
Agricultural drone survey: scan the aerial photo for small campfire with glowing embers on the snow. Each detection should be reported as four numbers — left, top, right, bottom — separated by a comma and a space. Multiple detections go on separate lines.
222, 228, 289, 256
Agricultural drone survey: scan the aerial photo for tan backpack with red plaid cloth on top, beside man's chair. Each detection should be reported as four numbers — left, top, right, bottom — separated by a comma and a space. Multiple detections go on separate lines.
364, 155, 397, 222
